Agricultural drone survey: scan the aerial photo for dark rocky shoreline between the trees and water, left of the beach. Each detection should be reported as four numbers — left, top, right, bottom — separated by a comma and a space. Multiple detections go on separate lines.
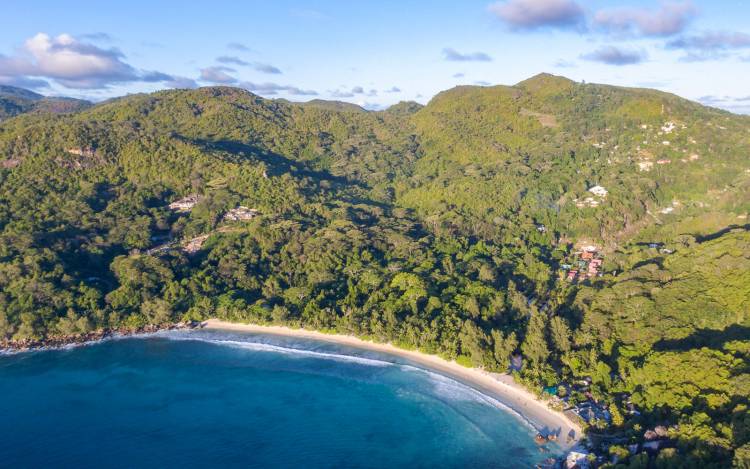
0, 321, 202, 353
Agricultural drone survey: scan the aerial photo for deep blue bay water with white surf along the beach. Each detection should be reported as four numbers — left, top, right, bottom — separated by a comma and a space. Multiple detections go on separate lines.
0, 331, 564, 468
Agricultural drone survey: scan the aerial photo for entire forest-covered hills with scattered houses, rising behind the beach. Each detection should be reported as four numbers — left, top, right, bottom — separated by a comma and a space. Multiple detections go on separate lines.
0, 74, 750, 467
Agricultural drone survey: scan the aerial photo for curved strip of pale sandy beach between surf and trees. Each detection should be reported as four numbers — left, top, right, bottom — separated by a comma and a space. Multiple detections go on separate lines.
203, 319, 582, 448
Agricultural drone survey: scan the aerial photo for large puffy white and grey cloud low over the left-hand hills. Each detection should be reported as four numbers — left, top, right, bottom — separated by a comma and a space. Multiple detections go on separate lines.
0, 33, 179, 89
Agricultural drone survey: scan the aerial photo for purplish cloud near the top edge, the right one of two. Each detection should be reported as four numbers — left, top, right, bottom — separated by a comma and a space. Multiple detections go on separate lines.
594, 1, 696, 37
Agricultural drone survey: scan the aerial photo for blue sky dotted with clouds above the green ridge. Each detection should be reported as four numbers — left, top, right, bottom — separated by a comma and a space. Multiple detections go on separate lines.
0, 0, 750, 112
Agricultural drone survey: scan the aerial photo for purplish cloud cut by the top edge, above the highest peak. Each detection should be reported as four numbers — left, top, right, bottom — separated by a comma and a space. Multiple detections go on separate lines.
489, 0, 586, 30
